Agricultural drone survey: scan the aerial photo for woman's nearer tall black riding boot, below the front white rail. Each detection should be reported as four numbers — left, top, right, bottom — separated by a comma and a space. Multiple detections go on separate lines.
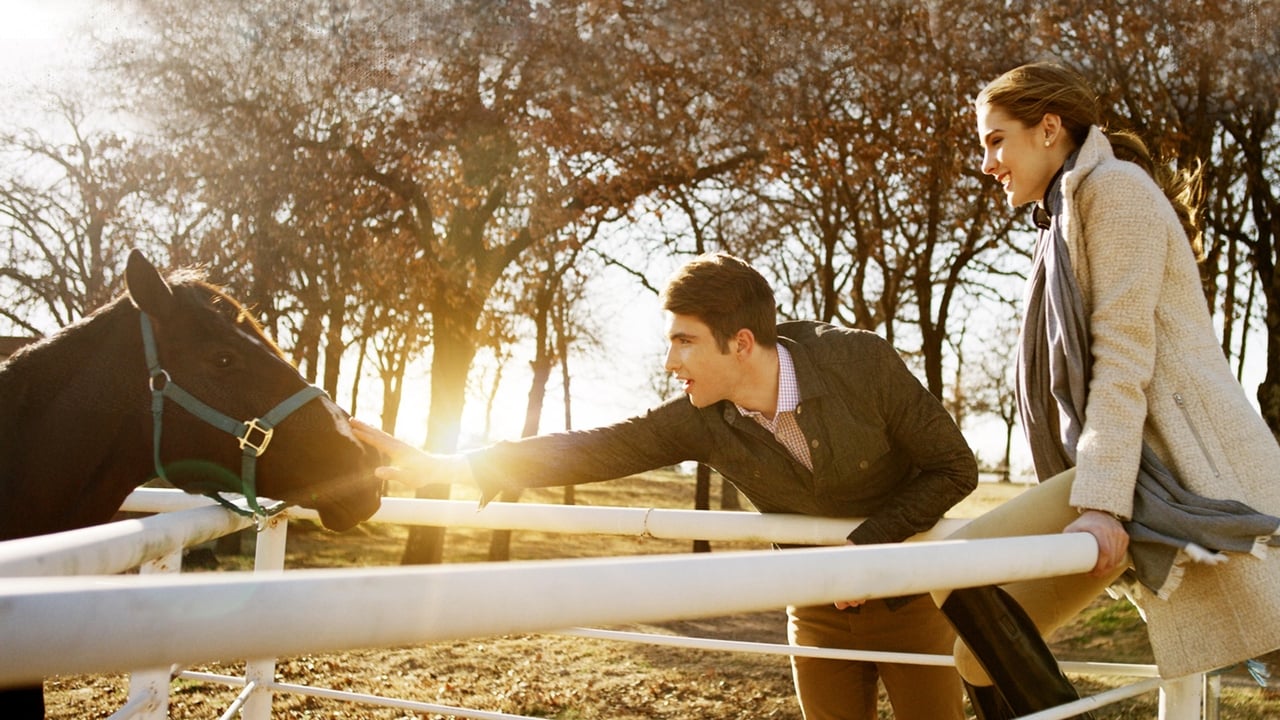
942, 585, 1091, 719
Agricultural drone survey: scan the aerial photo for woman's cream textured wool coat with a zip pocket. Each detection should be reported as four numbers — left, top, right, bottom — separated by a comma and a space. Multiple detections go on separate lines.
1062, 128, 1280, 678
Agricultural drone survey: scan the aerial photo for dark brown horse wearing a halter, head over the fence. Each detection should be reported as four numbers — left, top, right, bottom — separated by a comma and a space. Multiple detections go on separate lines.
0, 250, 383, 719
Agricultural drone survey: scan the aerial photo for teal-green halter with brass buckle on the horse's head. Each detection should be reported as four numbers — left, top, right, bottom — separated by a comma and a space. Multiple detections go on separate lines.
140, 313, 324, 530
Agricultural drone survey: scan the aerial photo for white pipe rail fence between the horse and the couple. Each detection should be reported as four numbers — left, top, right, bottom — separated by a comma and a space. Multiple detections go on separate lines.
0, 489, 1203, 720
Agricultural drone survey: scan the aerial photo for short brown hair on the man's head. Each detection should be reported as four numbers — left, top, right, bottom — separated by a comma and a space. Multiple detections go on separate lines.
662, 252, 778, 352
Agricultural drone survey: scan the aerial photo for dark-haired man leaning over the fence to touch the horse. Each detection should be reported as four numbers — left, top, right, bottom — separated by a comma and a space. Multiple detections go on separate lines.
358, 254, 978, 720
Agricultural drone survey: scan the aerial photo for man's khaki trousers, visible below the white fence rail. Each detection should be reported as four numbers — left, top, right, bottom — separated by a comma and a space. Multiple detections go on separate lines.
787, 596, 964, 720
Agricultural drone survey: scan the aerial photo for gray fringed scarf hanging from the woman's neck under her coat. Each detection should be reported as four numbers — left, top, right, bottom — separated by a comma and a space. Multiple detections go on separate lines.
1018, 155, 1280, 600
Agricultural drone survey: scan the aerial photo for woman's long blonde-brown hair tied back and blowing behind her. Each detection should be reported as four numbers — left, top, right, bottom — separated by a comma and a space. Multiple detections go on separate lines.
974, 63, 1204, 259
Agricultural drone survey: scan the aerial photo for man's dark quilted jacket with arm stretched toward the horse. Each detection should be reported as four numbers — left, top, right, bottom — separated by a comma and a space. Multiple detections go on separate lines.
468, 316, 978, 544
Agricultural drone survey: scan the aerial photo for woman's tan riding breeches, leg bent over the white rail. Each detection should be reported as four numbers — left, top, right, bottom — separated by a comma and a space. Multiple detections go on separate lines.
933, 468, 1126, 685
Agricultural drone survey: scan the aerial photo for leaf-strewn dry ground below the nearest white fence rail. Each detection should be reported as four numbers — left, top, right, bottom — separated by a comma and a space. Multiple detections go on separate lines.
46, 601, 1280, 720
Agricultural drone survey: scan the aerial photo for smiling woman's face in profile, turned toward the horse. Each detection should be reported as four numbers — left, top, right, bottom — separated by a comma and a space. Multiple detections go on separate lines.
975, 104, 1070, 208
